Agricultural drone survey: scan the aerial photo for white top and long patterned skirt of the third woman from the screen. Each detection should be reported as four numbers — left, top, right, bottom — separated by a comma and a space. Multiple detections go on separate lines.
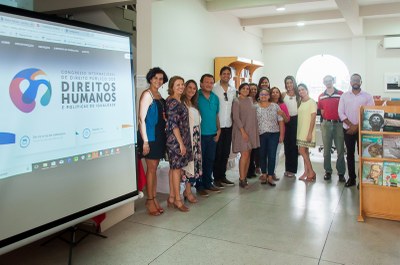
182, 107, 203, 184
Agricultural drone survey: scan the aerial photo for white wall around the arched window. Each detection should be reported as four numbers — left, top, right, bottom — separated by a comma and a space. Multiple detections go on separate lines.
263, 36, 400, 97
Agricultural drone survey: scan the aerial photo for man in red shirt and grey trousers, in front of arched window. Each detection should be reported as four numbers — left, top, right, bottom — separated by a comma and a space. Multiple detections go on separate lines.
318, 75, 346, 182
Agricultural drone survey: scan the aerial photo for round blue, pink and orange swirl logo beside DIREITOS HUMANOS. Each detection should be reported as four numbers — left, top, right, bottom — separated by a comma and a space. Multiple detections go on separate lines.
10, 68, 51, 113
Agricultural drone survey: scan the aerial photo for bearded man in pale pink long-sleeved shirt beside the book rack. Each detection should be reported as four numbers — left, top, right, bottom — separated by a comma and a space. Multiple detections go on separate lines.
338, 74, 375, 187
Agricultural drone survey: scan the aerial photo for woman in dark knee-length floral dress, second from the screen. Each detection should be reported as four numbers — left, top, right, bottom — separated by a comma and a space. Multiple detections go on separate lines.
166, 76, 193, 212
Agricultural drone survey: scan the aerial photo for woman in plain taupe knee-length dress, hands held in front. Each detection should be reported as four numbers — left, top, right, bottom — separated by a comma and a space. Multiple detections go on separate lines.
232, 83, 260, 188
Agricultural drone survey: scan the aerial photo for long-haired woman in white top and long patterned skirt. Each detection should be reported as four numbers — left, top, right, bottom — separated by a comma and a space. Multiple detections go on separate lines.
181, 79, 203, 203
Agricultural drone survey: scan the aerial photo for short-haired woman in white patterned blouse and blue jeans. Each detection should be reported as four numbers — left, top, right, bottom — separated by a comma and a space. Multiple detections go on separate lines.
257, 88, 284, 186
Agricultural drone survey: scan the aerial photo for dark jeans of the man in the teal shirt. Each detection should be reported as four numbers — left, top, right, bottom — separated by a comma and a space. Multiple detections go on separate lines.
196, 135, 217, 190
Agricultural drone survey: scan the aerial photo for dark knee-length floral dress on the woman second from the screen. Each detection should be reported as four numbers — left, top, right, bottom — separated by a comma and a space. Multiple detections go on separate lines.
166, 97, 193, 169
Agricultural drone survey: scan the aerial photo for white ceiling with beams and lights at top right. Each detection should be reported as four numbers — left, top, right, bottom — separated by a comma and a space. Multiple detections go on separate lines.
205, 0, 400, 40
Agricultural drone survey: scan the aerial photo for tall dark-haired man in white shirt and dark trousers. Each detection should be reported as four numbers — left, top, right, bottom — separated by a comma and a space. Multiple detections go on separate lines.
213, 66, 236, 188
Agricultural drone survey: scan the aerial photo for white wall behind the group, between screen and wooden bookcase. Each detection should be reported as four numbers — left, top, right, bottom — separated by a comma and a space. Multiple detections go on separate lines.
152, 0, 263, 95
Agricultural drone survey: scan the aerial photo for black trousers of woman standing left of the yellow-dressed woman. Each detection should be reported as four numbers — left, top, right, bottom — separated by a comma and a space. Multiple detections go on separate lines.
283, 116, 299, 173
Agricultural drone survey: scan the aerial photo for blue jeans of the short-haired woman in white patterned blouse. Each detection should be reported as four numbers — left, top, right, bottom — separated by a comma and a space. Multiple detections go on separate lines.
260, 132, 279, 176
